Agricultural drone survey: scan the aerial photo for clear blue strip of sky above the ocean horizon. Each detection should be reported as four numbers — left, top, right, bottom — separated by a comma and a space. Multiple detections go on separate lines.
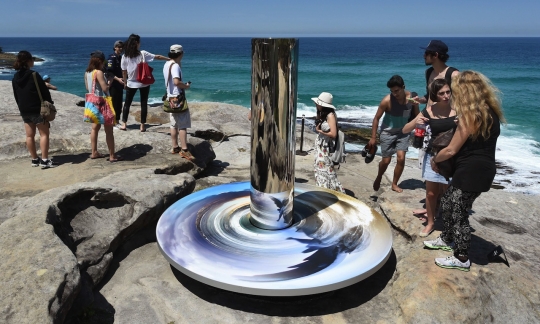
0, 0, 540, 37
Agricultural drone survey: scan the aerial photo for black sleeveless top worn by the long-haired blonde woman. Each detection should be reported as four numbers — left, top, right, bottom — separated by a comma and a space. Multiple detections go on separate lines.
452, 111, 501, 192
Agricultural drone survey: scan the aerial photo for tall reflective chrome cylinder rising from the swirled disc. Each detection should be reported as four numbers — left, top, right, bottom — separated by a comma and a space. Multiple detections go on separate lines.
250, 38, 298, 230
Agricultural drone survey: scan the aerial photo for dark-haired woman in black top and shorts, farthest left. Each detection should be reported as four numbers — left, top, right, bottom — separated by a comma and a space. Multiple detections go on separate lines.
12, 51, 57, 169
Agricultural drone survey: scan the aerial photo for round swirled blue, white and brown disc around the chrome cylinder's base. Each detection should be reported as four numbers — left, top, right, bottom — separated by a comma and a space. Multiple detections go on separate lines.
156, 182, 392, 296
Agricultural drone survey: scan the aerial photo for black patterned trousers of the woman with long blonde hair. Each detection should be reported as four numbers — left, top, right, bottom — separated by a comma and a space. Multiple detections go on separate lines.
441, 185, 480, 258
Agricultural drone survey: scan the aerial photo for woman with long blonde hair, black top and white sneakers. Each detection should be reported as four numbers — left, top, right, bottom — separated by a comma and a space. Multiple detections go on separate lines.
424, 71, 505, 271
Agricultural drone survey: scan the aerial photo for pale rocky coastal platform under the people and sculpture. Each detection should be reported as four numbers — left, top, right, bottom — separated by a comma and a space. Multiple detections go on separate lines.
0, 81, 540, 323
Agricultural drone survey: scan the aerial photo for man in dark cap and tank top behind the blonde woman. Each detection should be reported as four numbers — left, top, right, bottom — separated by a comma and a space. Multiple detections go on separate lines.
415, 39, 459, 105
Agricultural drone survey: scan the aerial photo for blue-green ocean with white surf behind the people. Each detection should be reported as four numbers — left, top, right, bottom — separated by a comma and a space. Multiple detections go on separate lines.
0, 35, 540, 194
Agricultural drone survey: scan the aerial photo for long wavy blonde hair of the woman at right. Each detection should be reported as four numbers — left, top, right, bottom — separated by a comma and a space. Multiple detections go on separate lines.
452, 71, 506, 140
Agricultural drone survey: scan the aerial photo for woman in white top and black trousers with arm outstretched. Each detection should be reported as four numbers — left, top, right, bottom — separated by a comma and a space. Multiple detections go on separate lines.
120, 34, 169, 132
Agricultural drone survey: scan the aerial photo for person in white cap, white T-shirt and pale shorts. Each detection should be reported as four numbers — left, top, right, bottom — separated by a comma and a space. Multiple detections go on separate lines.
163, 44, 194, 160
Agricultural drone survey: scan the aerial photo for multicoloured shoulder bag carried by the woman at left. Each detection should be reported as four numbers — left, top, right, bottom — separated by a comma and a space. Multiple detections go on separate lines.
83, 71, 116, 125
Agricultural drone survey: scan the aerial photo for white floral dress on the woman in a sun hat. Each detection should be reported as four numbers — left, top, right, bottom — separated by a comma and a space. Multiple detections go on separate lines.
313, 121, 345, 193
